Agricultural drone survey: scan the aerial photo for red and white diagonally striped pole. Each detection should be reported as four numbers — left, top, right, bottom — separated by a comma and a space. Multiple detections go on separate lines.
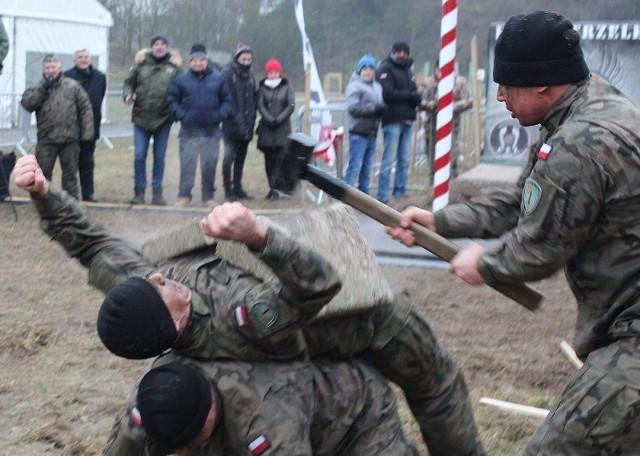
432, 0, 458, 212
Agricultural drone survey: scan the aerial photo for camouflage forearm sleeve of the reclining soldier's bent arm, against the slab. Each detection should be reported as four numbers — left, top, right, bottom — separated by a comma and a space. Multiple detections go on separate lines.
259, 227, 342, 316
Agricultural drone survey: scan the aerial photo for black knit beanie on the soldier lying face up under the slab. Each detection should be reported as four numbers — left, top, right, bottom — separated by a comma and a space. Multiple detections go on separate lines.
97, 277, 178, 359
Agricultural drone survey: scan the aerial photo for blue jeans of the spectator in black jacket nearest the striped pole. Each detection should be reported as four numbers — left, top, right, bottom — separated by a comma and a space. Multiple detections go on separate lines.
377, 123, 411, 202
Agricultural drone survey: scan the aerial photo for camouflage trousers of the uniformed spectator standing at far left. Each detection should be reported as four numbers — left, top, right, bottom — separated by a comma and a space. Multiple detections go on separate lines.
36, 142, 80, 199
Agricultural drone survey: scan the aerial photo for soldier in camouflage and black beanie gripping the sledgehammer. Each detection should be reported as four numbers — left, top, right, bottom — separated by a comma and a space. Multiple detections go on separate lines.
388, 11, 640, 455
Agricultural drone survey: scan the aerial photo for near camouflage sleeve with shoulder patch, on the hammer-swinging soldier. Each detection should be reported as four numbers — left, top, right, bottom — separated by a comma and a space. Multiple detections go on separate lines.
478, 127, 609, 284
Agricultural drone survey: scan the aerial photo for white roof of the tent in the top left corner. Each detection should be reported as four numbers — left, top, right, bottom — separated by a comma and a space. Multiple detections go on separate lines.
0, 0, 113, 27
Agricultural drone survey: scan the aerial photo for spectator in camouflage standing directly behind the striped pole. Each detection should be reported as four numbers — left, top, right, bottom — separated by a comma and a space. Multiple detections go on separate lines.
419, 60, 473, 175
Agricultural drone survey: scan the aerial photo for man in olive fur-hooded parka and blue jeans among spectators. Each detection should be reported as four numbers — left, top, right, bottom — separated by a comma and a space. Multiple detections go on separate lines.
122, 35, 182, 206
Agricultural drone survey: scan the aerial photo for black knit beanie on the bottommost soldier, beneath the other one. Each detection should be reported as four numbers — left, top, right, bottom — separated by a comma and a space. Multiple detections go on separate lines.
137, 362, 211, 450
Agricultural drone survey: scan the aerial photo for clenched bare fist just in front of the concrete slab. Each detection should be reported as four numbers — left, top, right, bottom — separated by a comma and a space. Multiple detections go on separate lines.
200, 202, 267, 251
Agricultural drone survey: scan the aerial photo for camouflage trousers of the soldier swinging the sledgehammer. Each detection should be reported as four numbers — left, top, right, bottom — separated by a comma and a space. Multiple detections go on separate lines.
525, 337, 640, 456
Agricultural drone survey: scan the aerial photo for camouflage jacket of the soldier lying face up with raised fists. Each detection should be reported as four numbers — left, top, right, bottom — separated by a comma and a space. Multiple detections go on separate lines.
34, 186, 341, 360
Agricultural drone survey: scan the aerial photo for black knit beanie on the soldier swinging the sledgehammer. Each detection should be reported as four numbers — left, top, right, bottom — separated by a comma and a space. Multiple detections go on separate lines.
493, 11, 589, 87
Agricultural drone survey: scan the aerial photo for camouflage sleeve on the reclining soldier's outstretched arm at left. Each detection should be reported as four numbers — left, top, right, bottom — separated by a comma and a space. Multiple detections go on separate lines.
33, 185, 153, 293
